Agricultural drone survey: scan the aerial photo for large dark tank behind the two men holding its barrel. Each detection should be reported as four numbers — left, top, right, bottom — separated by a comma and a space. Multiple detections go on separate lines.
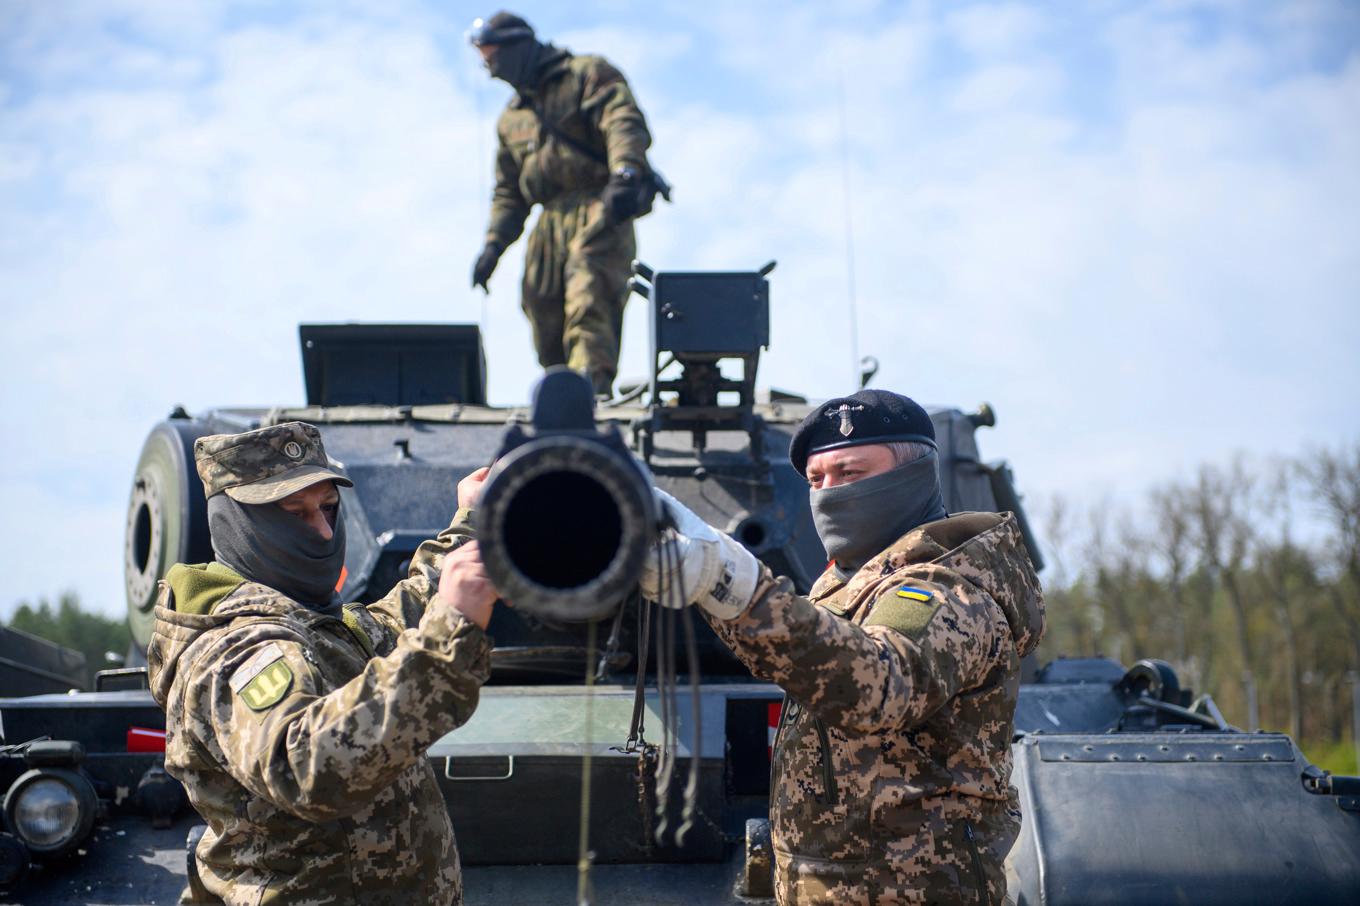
0, 263, 1360, 906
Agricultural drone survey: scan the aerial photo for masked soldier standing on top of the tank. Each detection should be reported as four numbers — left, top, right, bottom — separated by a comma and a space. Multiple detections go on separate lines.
469, 12, 651, 396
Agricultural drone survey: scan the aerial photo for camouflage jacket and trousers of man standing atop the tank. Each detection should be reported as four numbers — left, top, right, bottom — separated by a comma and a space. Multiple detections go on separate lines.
487, 49, 651, 378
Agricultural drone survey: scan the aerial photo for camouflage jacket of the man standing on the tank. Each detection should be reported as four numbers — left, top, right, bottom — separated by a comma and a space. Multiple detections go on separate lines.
487, 48, 651, 249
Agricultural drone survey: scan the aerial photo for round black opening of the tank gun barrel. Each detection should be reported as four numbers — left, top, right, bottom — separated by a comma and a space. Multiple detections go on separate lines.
503, 471, 623, 589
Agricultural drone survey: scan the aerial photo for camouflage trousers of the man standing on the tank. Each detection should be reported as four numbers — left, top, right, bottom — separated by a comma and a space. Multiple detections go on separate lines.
521, 190, 638, 382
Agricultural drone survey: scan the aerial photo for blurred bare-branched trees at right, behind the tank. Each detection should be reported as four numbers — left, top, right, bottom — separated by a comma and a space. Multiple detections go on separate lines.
1035, 443, 1360, 773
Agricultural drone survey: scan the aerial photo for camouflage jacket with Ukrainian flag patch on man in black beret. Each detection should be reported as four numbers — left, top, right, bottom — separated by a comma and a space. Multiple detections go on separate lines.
710, 513, 1043, 906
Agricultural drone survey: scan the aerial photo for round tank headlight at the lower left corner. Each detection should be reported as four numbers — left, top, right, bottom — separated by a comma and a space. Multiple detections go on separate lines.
4, 767, 98, 856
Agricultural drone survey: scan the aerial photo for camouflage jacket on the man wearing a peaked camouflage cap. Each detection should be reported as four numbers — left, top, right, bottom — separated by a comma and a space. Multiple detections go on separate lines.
147, 510, 491, 906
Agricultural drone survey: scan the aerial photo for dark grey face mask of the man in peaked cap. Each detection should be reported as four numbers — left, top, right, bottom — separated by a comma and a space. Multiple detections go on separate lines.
208, 494, 344, 611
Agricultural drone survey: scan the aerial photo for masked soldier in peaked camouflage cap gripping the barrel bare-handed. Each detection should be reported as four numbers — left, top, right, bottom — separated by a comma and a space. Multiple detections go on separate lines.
147, 422, 495, 906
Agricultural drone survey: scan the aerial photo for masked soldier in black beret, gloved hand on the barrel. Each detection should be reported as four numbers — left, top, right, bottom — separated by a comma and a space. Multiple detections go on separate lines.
642, 390, 1043, 906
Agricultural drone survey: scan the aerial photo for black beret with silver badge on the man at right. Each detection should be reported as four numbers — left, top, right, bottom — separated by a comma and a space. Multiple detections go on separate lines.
789, 390, 936, 475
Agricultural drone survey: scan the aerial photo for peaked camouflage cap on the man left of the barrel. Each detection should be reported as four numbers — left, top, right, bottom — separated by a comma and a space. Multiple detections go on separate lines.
193, 422, 354, 503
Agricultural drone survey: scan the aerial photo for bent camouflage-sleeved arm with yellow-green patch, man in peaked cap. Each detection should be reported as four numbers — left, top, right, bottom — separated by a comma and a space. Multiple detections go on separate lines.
182, 568, 494, 822
